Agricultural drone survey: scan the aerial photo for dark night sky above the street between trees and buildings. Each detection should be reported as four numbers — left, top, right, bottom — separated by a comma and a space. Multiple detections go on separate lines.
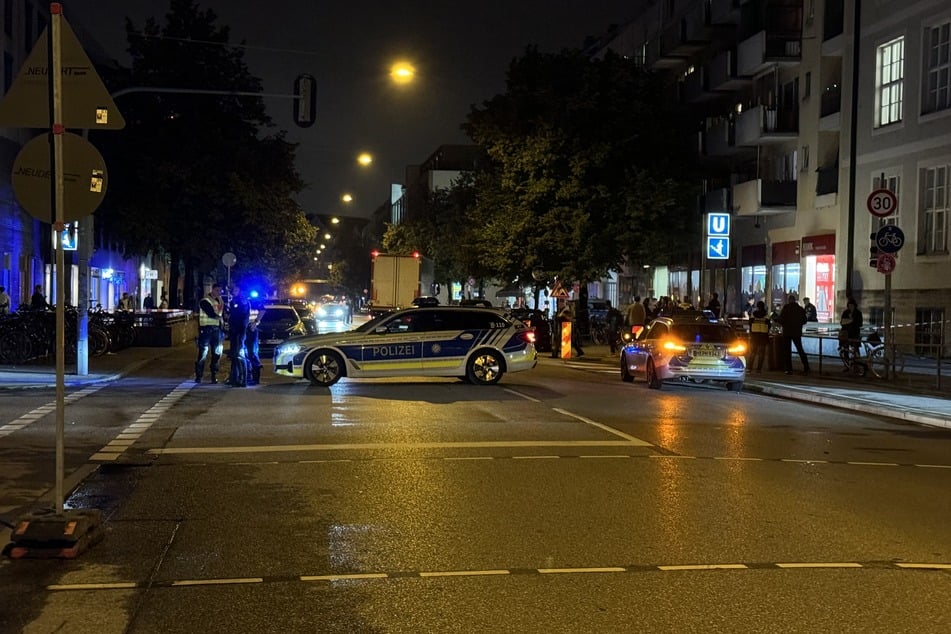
62, 0, 636, 216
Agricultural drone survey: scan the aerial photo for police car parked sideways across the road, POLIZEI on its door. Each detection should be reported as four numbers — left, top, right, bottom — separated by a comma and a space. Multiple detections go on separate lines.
274, 306, 538, 386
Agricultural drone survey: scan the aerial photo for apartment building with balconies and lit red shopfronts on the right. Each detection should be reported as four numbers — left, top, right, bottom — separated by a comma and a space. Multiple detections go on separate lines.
595, 0, 951, 353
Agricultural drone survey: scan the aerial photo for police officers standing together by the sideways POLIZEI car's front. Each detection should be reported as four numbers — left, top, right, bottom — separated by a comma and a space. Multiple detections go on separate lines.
195, 284, 261, 387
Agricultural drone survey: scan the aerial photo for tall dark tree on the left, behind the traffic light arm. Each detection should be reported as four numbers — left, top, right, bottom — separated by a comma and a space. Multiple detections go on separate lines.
91, 0, 316, 306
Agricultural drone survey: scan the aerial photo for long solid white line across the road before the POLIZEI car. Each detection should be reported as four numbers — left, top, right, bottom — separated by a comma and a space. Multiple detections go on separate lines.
149, 440, 642, 456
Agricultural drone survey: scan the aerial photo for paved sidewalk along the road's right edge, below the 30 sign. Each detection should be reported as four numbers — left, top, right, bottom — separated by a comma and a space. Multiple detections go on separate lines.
539, 344, 951, 429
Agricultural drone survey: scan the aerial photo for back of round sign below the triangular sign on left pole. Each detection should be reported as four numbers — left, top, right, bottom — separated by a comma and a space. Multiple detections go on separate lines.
11, 132, 107, 222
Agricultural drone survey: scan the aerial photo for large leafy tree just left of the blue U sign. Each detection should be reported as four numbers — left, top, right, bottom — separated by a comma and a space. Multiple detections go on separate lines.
464, 48, 699, 281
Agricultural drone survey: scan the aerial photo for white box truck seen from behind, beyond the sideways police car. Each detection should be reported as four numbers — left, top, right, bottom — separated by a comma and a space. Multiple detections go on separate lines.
370, 251, 433, 315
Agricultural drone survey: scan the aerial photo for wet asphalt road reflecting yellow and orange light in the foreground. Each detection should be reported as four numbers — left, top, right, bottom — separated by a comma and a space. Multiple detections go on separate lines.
0, 347, 951, 633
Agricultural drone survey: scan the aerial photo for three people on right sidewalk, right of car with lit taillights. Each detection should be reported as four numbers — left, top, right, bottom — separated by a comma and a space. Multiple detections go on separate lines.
747, 293, 863, 375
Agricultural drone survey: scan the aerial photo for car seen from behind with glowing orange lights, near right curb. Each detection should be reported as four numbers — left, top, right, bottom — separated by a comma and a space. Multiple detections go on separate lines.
620, 311, 747, 391
